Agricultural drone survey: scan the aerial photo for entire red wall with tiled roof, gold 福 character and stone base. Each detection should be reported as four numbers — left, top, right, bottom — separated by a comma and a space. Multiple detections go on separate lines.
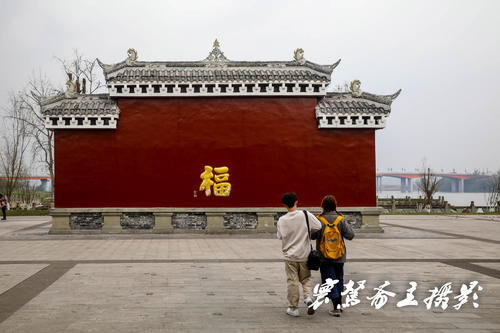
43, 41, 400, 232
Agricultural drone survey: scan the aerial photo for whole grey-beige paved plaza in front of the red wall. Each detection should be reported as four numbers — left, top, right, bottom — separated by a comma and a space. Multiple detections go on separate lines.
0, 215, 500, 333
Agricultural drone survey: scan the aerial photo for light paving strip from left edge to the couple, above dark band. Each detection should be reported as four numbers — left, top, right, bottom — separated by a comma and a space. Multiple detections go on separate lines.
0, 238, 281, 261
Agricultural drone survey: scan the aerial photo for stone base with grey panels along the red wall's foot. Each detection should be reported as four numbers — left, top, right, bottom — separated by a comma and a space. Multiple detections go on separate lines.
50, 207, 383, 234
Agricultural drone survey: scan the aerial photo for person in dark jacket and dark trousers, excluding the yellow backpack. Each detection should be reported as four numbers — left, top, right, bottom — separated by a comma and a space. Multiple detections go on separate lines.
311, 195, 354, 317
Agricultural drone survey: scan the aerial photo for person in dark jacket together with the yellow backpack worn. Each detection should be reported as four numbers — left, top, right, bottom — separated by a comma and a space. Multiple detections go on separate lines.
312, 195, 354, 317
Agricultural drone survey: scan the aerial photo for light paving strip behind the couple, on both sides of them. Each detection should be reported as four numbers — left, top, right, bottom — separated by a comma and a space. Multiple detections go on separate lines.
0, 238, 500, 261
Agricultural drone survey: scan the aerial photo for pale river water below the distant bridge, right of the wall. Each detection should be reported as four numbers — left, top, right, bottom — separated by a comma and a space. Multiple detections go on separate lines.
377, 191, 489, 206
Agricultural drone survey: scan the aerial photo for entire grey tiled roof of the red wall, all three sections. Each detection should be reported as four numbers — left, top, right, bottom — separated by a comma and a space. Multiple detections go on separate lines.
38, 41, 401, 129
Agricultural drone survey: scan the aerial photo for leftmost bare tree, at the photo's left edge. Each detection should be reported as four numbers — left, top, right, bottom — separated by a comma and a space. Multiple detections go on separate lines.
0, 95, 29, 198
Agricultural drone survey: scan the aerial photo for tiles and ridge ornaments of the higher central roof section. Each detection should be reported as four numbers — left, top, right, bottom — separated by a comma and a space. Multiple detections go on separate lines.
98, 41, 340, 89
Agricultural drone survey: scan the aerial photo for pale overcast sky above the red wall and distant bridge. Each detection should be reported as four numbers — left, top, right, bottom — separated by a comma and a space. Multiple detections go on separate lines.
0, 0, 500, 171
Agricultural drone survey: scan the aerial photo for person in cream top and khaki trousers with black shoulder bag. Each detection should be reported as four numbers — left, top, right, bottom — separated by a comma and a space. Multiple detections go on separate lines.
276, 193, 321, 317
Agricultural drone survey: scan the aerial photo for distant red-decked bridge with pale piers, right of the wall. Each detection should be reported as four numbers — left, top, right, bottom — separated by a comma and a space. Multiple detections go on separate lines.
377, 172, 492, 193
